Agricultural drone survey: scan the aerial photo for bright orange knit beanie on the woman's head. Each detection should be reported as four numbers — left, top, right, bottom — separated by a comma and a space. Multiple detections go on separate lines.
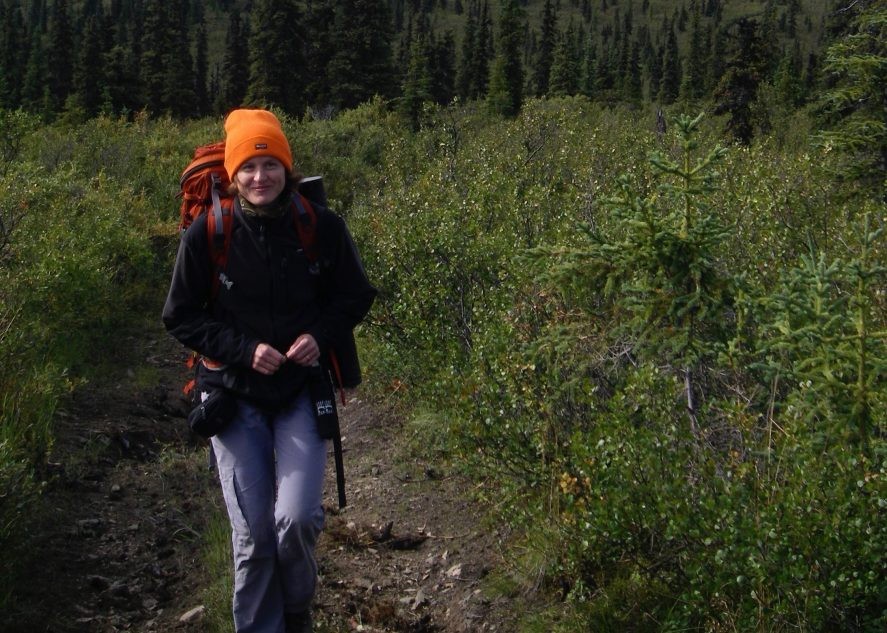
225, 110, 293, 180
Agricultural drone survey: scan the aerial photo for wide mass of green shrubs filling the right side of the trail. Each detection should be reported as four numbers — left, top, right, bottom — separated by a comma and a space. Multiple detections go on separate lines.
352, 100, 887, 631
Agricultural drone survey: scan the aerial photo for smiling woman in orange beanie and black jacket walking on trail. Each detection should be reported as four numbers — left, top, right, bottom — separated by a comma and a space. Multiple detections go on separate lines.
163, 109, 376, 633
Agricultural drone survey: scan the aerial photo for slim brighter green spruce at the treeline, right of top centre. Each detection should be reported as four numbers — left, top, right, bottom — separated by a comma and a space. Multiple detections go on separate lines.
487, 0, 524, 116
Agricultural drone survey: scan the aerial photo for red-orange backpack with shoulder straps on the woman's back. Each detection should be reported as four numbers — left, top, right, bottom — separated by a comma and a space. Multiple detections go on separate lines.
177, 141, 326, 297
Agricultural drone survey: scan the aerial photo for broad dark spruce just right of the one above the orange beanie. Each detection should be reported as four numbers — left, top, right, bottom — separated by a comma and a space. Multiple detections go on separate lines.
327, 0, 393, 108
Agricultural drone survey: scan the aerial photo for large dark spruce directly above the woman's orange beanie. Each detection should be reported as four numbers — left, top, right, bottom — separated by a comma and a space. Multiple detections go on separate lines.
246, 0, 306, 114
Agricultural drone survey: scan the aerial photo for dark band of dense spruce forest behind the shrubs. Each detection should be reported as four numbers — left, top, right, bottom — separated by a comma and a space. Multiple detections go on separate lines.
0, 0, 855, 135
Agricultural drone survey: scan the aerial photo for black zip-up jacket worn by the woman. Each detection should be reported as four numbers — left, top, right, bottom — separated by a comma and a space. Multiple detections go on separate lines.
163, 198, 376, 406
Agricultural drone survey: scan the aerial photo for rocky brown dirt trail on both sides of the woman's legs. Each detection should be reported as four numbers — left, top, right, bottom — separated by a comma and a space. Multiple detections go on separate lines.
6, 327, 510, 633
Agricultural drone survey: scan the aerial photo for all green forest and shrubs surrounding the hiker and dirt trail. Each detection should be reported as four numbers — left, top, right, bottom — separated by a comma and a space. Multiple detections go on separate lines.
0, 0, 887, 633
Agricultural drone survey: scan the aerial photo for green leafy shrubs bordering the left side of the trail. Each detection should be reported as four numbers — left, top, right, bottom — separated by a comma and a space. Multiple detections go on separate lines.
0, 115, 181, 600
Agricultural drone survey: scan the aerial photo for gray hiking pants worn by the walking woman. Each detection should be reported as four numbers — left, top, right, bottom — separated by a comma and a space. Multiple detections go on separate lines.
212, 390, 327, 633
